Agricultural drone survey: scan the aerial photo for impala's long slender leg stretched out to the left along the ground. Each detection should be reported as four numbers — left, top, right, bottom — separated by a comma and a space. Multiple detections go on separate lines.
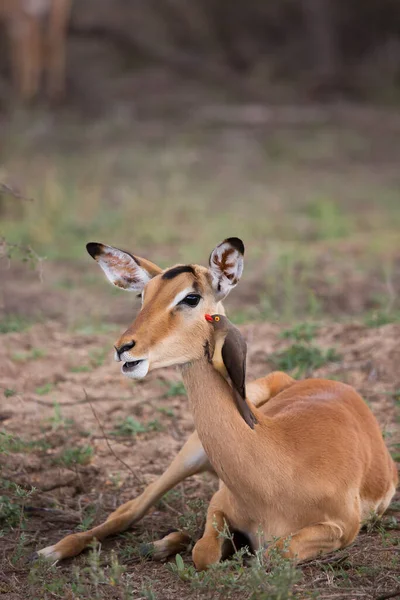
38, 432, 212, 560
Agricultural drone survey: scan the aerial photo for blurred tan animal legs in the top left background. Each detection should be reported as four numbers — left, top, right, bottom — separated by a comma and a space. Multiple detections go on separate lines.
0, 0, 72, 102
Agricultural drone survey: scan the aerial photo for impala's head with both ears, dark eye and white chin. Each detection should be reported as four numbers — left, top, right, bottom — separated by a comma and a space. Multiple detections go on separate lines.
86, 238, 244, 378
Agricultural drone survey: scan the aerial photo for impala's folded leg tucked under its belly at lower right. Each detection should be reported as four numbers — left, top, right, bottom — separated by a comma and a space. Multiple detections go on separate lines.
266, 521, 360, 561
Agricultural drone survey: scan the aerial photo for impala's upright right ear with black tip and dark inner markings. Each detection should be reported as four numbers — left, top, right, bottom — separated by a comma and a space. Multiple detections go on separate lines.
210, 238, 244, 300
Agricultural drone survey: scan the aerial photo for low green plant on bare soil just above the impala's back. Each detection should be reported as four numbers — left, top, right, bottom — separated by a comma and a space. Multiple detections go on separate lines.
269, 342, 340, 377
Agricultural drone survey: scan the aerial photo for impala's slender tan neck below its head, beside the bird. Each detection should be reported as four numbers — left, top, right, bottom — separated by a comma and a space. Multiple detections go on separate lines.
182, 358, 273, 491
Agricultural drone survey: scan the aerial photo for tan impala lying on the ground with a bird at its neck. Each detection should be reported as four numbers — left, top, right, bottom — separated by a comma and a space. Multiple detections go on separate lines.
40, 238, 397, 569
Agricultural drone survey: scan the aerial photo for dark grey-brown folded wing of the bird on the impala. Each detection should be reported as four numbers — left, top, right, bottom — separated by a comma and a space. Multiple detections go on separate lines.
222, 325, 247, 398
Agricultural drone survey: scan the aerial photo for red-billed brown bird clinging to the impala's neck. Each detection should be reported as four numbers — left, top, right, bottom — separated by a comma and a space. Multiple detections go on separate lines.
205, 314, 257, 429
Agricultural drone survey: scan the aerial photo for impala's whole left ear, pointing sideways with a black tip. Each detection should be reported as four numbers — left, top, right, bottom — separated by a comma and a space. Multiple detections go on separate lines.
86, 242, 162, 292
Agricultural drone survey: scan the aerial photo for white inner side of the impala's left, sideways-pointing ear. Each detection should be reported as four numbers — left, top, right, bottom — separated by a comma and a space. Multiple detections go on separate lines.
96, 246, 151, 292
